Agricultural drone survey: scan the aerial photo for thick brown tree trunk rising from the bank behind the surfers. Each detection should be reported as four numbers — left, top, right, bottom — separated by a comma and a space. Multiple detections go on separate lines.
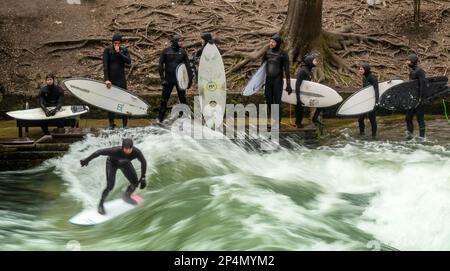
281, 0, 323, 62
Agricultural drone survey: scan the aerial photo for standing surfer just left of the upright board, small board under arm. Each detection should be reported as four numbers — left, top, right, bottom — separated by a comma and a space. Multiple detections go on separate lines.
158, 35, 192, 122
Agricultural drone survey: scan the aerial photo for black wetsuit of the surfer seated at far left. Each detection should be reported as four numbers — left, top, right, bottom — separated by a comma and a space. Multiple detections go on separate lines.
39, 84, 64, 135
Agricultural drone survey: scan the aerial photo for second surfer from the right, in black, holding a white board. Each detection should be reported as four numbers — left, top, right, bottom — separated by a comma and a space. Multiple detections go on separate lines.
358, 63, 380, 138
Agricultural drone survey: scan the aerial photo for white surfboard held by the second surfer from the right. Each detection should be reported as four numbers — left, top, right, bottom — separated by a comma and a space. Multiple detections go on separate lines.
336, 80, 403, 116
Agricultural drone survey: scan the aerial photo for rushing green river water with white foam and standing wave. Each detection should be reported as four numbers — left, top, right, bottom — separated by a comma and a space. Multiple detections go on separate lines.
0, 120, 450, 250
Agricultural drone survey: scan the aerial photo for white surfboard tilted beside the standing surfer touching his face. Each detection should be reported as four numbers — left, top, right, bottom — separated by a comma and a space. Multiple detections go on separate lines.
63, 78, 149, 116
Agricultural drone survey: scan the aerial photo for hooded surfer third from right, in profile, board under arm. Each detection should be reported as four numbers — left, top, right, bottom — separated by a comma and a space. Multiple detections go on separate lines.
295, 54, 323, 128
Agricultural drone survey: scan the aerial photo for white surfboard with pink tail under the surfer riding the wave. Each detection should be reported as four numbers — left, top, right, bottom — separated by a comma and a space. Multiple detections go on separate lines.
69, 195, 144, 226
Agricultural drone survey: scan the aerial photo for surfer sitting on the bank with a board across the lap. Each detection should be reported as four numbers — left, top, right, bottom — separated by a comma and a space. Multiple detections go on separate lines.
39, 73, 64, 135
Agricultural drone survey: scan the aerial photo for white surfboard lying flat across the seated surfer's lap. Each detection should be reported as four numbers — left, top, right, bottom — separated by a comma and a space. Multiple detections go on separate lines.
6, 105, 89, 120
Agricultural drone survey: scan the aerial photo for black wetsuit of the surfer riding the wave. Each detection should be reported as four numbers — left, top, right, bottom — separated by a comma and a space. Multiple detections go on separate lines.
84, 147, 147, 205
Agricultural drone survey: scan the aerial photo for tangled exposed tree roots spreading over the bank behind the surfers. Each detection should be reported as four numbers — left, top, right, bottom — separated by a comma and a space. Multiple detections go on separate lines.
30, 0, 450, 94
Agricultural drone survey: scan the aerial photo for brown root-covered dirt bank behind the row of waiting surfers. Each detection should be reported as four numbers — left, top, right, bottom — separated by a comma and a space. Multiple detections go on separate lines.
0, 0, 450, 96
